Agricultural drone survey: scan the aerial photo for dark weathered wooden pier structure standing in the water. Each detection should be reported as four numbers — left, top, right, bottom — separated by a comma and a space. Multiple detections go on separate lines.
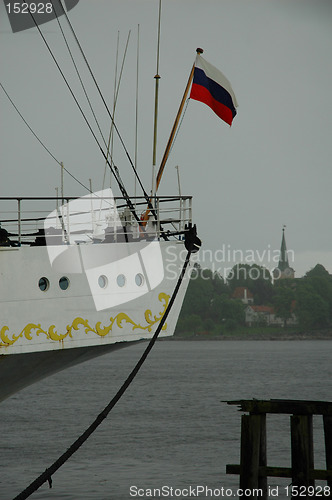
226, 399, 332, 499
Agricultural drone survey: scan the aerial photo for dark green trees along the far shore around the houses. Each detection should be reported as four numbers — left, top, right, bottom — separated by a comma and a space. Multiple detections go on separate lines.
176, 264, 332, 334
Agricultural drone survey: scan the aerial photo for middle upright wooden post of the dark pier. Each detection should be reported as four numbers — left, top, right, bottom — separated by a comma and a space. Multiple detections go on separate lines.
290, 415, 315, 494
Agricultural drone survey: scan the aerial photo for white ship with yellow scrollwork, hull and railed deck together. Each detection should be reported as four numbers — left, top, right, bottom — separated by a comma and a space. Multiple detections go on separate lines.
0, 190, 197, 400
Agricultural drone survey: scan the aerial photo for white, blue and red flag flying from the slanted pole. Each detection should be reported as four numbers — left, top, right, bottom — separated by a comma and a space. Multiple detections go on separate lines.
189, 55, 238, 125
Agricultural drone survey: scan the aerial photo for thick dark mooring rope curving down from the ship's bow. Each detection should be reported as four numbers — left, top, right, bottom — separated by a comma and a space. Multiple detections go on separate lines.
14, 247, 196, 500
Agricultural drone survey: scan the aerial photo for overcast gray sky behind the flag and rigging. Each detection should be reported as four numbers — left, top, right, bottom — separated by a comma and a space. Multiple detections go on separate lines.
0, 0, 332, 277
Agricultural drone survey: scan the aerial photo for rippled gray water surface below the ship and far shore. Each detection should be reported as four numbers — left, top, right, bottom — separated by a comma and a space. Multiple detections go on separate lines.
0, 340, 332, 500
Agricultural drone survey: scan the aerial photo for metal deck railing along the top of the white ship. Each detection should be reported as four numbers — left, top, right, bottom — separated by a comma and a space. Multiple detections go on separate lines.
0, 196, 192, 247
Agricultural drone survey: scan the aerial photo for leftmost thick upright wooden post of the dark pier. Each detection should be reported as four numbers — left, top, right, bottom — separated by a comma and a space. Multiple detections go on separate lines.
240, 415, 262, 498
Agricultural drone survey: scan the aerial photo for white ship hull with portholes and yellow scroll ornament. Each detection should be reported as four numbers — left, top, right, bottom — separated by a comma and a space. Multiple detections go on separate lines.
0, 240, 190, 400
